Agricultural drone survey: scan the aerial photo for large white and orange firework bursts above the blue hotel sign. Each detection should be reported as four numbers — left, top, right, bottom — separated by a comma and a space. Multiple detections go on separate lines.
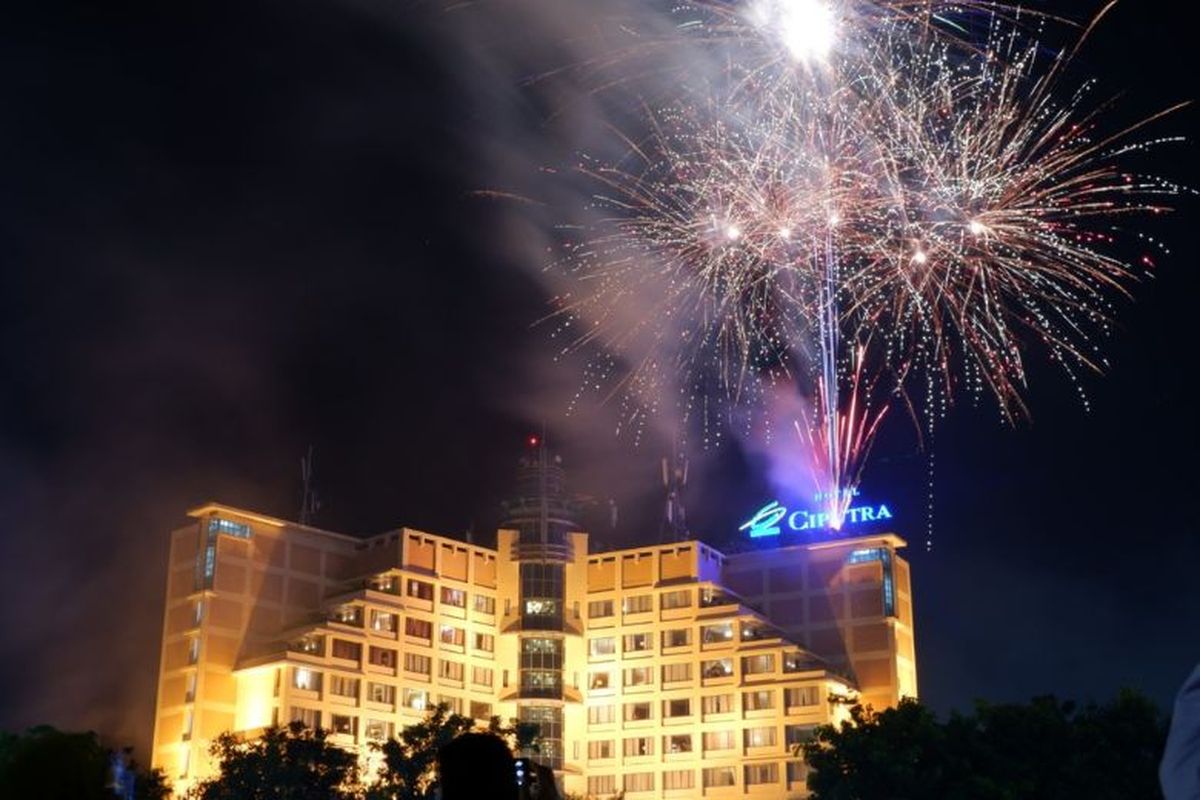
547, 0, 1184, 527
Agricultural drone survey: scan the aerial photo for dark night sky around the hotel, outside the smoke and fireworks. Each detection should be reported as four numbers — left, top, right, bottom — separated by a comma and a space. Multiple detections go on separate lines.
0, 0, 1200, 756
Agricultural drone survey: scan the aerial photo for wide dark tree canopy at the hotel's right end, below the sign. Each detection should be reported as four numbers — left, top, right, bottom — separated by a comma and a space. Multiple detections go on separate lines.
802, 691, 1166, 800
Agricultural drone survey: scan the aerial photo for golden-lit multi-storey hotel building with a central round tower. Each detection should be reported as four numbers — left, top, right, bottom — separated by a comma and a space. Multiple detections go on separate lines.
152, 458, 917, 800
